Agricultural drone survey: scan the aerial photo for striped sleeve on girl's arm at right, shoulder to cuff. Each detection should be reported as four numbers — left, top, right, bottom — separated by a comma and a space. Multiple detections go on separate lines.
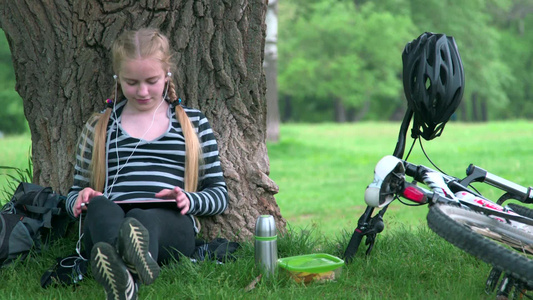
186, 111, 228, 216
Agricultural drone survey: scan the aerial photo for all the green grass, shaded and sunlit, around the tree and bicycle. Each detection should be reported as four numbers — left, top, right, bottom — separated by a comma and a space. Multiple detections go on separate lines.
0, 121, 533, 299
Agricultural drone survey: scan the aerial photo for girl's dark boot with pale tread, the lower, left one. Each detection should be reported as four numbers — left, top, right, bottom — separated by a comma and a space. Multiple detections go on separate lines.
91, 242, 137, 300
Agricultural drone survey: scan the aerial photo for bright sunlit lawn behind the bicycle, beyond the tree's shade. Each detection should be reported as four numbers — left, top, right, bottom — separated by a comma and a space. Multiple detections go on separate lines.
0, 121, 533, 236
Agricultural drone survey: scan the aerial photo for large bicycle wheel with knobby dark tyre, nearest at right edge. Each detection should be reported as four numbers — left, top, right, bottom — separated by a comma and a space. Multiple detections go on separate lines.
427, 204, 533, 288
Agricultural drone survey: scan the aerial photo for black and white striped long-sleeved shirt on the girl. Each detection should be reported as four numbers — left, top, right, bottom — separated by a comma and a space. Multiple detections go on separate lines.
66, 101, 228, 227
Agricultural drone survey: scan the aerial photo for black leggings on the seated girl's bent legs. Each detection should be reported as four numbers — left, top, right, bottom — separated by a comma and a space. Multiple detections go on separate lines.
83, 196, 196, 264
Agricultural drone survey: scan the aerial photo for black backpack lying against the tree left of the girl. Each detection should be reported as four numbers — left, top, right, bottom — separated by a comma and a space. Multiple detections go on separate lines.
0, 182, 72, 266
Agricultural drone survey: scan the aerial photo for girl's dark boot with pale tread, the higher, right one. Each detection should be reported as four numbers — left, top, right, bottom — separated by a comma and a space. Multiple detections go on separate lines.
118, 218, 160, 285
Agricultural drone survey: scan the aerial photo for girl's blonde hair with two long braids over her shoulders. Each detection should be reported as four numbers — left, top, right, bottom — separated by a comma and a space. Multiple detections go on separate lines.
90, 28, 203, 192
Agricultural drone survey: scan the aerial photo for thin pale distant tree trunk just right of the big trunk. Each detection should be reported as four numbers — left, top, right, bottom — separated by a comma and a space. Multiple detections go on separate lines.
264, 0, 280, 142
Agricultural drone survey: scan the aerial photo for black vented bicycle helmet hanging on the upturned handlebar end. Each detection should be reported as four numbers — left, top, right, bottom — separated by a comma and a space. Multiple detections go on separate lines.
402, 32, 465, 140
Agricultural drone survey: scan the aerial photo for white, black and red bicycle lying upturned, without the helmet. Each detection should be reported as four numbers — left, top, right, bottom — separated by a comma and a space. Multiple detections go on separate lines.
344, 109, 533, 297
